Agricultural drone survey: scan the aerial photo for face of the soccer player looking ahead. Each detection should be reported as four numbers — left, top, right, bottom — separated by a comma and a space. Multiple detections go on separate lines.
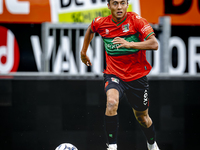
108, 0, 128, 21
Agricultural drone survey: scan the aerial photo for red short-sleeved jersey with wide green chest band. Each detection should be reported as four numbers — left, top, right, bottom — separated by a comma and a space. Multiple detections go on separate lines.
91, 12, 154, 82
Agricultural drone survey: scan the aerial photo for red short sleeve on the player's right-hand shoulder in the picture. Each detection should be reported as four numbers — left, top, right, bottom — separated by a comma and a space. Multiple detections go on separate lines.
134, 15, 155, 40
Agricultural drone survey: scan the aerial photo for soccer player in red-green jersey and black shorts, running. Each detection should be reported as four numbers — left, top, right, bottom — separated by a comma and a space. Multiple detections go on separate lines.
81, 0, 159, 150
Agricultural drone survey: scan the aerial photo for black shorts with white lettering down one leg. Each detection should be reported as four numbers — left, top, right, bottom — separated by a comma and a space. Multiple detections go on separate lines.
104, 74, 149, 111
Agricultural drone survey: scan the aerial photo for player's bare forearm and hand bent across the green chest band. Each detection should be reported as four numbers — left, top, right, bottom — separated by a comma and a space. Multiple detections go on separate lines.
112, 35, 158, 50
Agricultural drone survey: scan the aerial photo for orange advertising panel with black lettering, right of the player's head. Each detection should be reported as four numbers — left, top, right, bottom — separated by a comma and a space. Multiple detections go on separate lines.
140, 0, 200, 26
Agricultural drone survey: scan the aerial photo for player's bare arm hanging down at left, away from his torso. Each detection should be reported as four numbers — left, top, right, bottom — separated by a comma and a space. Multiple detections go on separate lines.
81, 25, 94, 66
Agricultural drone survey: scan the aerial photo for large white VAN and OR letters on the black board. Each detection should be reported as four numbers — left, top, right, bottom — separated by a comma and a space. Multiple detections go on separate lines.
31, 36, 200, 75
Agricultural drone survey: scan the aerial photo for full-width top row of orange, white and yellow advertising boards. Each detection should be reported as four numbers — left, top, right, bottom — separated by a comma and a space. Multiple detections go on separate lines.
0, 0, 200, 26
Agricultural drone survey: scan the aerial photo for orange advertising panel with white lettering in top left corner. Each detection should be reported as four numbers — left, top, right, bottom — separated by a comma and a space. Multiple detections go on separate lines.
0, 0, 51, 23
